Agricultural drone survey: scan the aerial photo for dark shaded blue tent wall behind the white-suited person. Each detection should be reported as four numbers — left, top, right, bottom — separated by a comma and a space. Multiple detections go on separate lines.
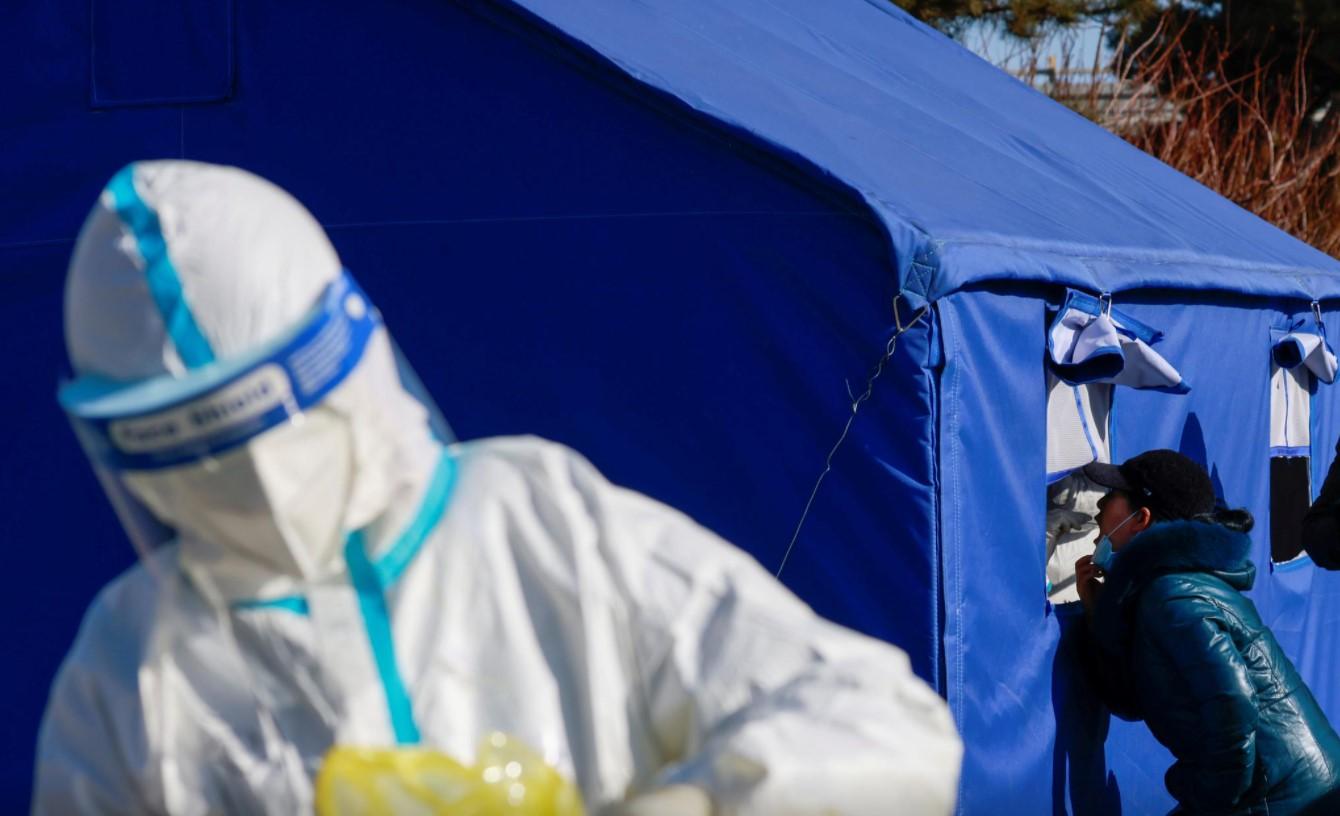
0, 0, 937, 812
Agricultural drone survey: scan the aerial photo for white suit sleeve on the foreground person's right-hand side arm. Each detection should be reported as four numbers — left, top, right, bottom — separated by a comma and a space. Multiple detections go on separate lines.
554, 454, 962, 816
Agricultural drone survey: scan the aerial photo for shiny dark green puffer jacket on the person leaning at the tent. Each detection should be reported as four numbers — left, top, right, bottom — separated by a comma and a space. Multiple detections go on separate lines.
1088, 521, 1340, 816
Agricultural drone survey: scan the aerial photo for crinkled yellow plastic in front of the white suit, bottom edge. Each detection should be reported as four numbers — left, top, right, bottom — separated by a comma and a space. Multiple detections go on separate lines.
316, 733, 583, 816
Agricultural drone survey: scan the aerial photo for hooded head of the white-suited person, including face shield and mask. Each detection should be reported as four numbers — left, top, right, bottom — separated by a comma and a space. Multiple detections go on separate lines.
60, 161, 434, 602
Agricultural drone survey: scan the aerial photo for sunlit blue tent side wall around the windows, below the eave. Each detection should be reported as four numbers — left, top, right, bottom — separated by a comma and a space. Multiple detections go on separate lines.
938, 288, 1340, 815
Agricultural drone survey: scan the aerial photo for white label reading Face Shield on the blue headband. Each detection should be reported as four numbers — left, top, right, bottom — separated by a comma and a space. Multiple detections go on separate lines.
107, 363, 293, 453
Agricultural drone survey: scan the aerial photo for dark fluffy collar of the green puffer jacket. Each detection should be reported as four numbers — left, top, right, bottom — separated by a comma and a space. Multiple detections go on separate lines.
1093, 521, 1256, 646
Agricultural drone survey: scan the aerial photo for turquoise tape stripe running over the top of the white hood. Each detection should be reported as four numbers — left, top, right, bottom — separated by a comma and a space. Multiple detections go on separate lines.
107, 165, 214, 368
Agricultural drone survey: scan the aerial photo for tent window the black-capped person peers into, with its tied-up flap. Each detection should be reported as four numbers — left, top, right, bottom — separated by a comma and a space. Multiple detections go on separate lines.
1047, 292, 1189, 604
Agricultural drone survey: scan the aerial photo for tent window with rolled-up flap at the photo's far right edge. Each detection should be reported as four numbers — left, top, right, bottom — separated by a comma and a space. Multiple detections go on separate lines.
1270, 304, 1336, 564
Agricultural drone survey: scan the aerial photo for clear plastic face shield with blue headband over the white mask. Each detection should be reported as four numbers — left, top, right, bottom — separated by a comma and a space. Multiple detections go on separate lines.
59, 273, 452, 579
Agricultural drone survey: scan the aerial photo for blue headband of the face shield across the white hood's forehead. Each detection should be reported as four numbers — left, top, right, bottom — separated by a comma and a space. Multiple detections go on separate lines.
59, 271, 382, 470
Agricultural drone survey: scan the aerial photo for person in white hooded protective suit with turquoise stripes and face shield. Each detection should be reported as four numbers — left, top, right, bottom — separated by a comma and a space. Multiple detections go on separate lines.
34, 161, 961, 816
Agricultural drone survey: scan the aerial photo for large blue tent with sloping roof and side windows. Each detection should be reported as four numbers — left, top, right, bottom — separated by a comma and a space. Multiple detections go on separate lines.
0, 0, 1340, 813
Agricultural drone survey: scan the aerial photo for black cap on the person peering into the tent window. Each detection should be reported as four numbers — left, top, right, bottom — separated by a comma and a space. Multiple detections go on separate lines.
1084, 450, 1215, 520
